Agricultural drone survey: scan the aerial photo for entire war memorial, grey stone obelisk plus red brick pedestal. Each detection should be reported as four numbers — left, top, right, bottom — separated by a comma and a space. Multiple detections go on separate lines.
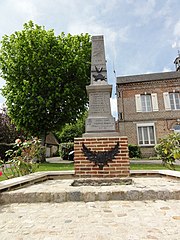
74, 36, 129, 178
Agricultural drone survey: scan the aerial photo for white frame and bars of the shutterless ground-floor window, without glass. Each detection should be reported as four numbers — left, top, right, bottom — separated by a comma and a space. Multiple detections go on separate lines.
136, 123, 157, 146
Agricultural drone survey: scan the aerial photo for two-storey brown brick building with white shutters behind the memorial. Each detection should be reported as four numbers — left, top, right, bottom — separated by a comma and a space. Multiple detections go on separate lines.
117, 55, 180, 157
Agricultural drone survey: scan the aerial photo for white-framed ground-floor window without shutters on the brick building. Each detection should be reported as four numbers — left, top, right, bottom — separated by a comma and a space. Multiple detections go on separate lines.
137, 124, 156, 145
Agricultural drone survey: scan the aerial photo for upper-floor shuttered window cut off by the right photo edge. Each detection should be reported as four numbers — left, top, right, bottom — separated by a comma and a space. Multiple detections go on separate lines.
163, 92, 180, 111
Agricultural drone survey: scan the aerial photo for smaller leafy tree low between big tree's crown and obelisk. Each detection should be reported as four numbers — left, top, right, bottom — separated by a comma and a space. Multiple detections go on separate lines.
56, 112, 87, 143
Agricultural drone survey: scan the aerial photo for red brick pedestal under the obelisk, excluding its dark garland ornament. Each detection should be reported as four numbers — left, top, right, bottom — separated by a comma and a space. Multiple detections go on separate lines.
74, 137, 130, 178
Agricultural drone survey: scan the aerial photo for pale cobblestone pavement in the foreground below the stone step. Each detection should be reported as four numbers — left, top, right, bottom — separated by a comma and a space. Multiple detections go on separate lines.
0, 200, 180, 240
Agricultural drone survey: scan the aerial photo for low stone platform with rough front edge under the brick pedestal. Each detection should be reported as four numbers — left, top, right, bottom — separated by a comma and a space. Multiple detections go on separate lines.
0, 170, 180, 204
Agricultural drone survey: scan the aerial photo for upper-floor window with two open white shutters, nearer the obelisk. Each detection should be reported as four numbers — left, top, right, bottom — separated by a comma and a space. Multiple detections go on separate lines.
135, 93, 158, 112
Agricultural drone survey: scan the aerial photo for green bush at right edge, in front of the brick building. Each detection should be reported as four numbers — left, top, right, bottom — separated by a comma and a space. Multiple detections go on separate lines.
155, 133, 180, 169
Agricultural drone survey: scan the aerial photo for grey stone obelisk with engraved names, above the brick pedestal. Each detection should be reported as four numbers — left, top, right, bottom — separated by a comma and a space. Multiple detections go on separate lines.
83, 36, 119, 137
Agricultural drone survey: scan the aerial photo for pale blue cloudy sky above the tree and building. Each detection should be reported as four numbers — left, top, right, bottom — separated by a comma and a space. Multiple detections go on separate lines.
0, 0, 180, 117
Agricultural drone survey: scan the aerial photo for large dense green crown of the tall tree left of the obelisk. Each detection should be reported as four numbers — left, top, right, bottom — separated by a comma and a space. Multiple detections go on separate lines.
0, 21, 91, 143
